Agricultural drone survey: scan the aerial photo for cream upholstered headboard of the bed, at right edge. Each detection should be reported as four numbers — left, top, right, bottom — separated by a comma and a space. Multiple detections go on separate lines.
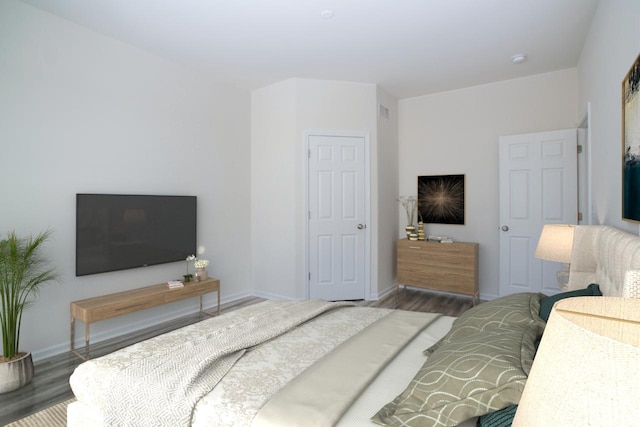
567, 225, 640, 297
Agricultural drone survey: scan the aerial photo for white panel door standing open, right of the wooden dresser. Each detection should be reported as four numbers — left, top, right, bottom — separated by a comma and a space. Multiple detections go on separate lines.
499, 129, 578, 295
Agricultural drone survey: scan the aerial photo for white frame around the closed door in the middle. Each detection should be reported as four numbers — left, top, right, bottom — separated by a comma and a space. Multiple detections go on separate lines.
302, 130, 371, 300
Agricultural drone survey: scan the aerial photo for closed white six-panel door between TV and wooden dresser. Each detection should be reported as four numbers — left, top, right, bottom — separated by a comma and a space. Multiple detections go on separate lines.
308, 135, 366, 301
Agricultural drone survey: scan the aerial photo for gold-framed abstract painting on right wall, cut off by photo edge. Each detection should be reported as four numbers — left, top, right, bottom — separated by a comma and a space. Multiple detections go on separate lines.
622, 51, 640, 222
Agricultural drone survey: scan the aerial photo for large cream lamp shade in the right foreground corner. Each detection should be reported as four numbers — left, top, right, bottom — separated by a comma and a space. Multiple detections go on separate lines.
513, 297, 640, 427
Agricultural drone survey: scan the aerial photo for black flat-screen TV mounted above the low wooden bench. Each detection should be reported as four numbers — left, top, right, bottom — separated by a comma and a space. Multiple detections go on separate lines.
76, 194, 197, 276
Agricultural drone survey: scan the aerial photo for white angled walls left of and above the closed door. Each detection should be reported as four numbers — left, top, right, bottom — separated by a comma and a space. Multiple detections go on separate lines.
251, 79, 395, 299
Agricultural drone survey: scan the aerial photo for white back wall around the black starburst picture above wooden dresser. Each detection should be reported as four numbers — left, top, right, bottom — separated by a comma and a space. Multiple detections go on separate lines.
397, 69, 578, 298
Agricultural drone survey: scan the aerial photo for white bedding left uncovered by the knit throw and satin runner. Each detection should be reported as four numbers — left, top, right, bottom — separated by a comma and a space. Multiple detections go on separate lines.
68, 307, 464, 426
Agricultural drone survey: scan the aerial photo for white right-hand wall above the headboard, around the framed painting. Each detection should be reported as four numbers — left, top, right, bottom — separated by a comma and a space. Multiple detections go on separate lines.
578, 0, 640, 234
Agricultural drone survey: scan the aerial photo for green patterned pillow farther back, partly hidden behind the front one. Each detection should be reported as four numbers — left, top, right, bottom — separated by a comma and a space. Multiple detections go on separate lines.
424, 292, 545, 355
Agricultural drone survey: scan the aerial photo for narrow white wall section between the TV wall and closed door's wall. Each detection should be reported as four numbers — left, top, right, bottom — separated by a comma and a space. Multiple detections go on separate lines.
247, 80, 304, 299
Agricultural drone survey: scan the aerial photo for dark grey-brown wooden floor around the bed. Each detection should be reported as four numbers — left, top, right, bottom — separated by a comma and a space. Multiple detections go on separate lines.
0, 288, 472, 426
